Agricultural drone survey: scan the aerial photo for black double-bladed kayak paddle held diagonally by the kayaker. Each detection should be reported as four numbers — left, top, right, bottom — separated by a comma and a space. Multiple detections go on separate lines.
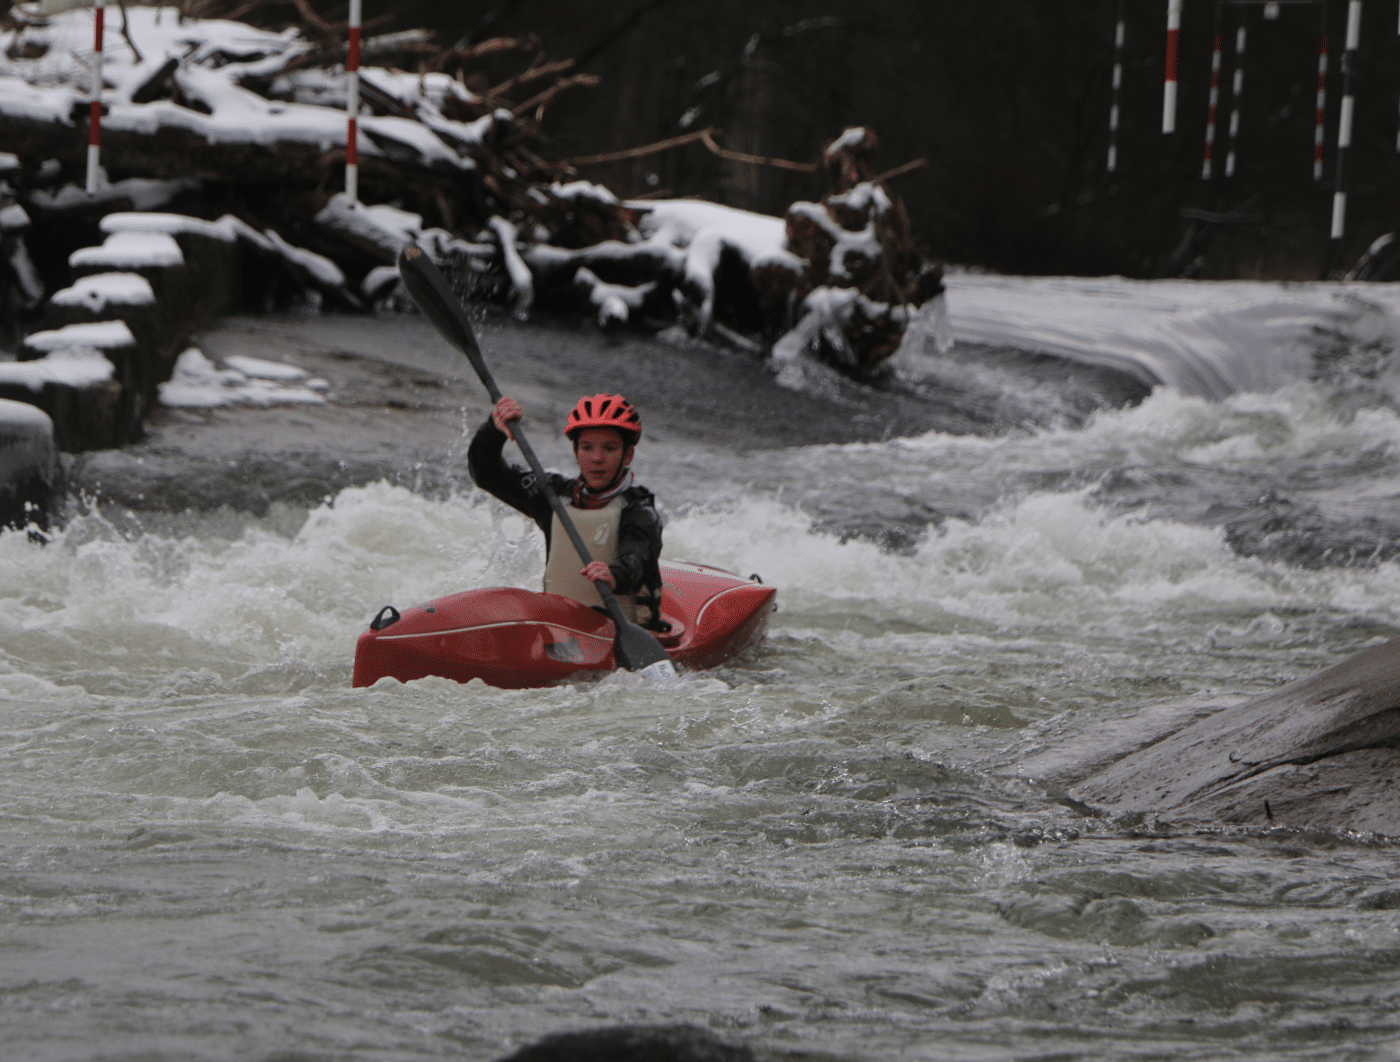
399, 243, 678, 683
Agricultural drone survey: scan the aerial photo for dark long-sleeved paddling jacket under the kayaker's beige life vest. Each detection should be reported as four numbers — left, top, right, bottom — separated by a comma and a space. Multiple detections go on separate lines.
466, 420, 664, 630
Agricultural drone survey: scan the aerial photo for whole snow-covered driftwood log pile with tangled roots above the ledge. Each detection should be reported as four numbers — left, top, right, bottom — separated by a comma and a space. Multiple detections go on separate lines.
0, 4, 942, 386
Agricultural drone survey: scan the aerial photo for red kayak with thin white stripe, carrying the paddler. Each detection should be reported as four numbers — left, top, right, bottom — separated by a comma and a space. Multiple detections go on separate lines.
354, 561, 774, 690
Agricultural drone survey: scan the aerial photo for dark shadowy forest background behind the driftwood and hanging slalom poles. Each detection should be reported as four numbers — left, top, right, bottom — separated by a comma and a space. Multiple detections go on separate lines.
10, 0, 1400, 278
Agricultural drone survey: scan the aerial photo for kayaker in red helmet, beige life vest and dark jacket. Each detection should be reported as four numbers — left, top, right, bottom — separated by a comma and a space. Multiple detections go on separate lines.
466, 395, 668, 630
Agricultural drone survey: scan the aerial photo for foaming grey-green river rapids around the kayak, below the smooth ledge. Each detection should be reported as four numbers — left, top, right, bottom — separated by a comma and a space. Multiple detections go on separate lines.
0, 284, 1400, 1062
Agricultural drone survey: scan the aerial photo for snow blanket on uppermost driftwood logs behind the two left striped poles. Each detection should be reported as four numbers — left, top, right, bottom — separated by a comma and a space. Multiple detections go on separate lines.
0, 4, 480, 174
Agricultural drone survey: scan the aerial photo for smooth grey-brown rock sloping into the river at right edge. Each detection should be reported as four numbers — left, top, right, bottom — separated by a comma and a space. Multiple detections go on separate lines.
1070, 638, 1400, 837
